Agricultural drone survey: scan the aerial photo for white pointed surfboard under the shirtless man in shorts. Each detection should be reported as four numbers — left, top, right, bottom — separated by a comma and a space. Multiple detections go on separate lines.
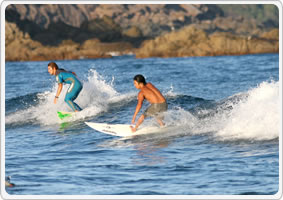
85, 122, 169, 137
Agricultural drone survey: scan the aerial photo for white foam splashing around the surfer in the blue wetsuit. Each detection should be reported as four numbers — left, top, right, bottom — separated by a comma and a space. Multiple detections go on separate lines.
6, 69, 131, 125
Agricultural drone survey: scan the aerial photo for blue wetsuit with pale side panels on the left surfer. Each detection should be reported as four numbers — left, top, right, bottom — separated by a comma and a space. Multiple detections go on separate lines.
56, 69, 83, 111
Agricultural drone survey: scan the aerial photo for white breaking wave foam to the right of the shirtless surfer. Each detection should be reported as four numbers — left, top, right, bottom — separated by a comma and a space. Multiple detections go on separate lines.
160, 81, 280, 140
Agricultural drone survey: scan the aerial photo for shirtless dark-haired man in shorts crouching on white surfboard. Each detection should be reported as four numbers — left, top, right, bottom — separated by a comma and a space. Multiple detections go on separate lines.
130, 74, 168, 132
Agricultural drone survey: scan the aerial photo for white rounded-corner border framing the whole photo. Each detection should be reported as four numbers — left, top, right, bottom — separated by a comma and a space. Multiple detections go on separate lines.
0, 0, 283, 200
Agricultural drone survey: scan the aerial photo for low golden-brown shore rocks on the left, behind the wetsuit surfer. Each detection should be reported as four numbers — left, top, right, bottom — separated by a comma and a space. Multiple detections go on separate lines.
5, 22, 133, 61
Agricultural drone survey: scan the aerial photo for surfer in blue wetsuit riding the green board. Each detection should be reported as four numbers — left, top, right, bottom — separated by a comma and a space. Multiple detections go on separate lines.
48, 62, 83, 112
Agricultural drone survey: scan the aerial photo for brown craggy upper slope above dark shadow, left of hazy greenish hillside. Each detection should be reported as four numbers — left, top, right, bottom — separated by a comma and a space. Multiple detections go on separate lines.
6, 4, 226, 37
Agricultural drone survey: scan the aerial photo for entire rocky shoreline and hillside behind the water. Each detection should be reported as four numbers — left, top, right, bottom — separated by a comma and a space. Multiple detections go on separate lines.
5, 4, 279, 61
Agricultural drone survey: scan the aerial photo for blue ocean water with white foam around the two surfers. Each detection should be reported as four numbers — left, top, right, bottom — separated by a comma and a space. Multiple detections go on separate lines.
1, 54, 280, 195
